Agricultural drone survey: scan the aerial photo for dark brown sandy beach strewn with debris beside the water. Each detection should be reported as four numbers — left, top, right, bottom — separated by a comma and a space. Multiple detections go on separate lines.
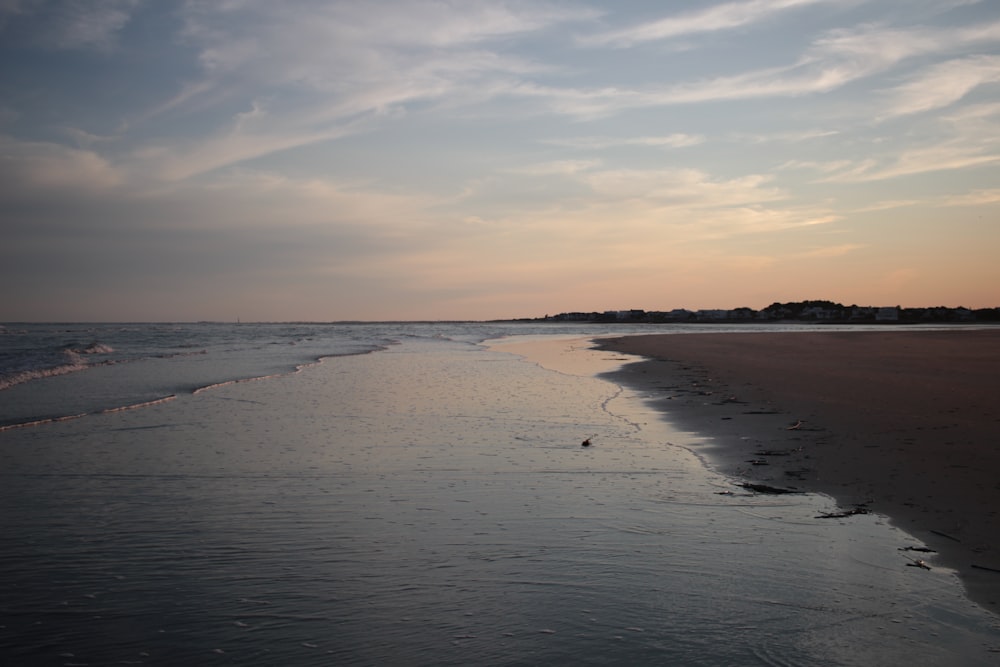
599, 329, 1000, 613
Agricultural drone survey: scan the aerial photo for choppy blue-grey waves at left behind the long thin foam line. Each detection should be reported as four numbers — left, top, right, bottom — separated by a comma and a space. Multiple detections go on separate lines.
0, 324, 394, 428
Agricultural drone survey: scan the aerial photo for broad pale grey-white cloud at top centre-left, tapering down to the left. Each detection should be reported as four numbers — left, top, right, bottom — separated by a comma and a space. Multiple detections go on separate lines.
123, 0, 595, 179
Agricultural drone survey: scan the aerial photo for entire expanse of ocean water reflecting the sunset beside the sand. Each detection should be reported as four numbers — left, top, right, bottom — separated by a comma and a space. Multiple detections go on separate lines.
0, 323, 1000, 665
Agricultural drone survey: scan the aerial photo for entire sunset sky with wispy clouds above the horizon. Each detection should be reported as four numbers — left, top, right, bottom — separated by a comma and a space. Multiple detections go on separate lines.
0, 0, 1000, 322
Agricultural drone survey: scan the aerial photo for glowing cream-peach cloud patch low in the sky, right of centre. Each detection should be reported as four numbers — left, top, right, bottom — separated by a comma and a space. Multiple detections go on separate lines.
463, 169, 838, 245
